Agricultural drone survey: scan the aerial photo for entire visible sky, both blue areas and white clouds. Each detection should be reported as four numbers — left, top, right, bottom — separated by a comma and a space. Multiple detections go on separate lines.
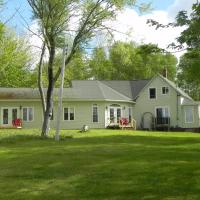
0, 0, 196, 58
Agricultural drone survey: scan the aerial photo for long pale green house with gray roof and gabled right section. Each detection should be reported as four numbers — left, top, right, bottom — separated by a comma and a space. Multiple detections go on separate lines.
0, 75, 200, 129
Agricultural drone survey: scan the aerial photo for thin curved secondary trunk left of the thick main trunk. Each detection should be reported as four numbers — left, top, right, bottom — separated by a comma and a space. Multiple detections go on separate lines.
38, 42, 46, 117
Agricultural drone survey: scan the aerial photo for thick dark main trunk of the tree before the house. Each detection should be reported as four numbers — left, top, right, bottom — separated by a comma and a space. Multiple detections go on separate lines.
41, 46, 55, 137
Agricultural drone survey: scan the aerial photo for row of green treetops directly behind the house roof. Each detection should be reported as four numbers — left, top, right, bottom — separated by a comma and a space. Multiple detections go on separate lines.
89, 42, 177, 80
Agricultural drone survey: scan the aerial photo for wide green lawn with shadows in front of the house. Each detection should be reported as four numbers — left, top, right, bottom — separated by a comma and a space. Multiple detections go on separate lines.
0, 130, 200, 200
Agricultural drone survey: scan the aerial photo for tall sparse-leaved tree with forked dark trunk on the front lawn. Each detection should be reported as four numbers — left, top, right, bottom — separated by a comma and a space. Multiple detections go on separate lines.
28, 0, 152, 137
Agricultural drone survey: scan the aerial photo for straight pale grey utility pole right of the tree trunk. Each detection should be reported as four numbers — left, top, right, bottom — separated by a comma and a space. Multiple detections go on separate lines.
55, 47, 66, 141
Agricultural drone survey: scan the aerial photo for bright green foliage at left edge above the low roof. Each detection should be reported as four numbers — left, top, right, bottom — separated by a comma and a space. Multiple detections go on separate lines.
0, 24, 32, 87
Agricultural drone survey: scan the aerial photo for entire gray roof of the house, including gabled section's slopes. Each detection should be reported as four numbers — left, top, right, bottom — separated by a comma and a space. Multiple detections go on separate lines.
0, 76, 192, 102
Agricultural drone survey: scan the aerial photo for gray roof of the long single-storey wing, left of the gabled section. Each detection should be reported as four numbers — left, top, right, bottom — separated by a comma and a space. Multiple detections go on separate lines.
0, 81, 132, 102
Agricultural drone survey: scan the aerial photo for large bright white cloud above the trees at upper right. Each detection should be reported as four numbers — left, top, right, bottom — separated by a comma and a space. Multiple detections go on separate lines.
109, 0, 196, 58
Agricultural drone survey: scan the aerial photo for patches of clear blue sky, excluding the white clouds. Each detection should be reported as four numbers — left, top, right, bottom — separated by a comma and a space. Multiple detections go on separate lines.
1, 0, 175, 33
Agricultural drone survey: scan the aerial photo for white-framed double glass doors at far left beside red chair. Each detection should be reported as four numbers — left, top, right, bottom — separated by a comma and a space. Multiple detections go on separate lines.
1, 108, 19, 126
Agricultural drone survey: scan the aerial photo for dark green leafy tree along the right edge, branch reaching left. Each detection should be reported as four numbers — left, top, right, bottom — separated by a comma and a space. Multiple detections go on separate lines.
147, 1, 200, 100
